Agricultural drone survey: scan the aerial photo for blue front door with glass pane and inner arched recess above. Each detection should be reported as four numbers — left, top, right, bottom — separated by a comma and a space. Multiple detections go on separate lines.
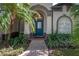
33, 10, 44, 37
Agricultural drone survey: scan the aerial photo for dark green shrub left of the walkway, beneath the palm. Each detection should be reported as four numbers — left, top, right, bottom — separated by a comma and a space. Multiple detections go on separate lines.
9, 34, 28, 48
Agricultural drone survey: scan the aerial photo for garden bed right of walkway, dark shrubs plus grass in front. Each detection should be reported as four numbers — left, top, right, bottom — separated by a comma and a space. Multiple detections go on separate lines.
45, 34, 79, 56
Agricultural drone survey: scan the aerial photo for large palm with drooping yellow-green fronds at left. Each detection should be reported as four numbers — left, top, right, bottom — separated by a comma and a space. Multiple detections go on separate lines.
0, 3, 34, 47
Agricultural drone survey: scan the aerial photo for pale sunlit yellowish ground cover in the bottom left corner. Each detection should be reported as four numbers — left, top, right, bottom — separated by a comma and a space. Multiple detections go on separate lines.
0, 47, 24, 56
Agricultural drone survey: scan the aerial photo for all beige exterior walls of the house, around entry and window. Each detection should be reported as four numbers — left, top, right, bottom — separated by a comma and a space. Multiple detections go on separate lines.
0, 3, 70, 34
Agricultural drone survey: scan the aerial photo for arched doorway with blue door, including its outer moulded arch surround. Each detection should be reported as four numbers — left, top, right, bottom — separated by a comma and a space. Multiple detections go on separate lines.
31, 4, 48, 37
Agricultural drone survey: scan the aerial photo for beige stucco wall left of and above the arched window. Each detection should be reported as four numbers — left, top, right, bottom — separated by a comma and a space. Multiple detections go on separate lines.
53, 5, 71, 33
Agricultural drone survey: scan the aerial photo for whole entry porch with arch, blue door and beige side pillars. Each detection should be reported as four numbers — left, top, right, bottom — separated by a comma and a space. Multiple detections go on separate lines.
24, 5, 52, 38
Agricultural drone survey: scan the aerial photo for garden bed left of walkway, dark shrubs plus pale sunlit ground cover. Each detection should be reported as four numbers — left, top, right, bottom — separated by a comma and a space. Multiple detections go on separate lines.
0, 33, 31, 56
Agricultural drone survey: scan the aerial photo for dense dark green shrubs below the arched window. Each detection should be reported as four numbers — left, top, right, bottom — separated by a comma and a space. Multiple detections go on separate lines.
46, 34, 71, 48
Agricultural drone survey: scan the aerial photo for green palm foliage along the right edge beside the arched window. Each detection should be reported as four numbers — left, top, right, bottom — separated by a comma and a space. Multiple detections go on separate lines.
70, 4, 79, 45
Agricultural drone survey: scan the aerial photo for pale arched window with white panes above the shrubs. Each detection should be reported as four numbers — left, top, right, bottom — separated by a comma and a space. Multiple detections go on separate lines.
57, 16, 72, 34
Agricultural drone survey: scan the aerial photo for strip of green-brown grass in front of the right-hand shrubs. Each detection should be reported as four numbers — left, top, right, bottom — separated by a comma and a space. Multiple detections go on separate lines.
50, 48, 79, 56
